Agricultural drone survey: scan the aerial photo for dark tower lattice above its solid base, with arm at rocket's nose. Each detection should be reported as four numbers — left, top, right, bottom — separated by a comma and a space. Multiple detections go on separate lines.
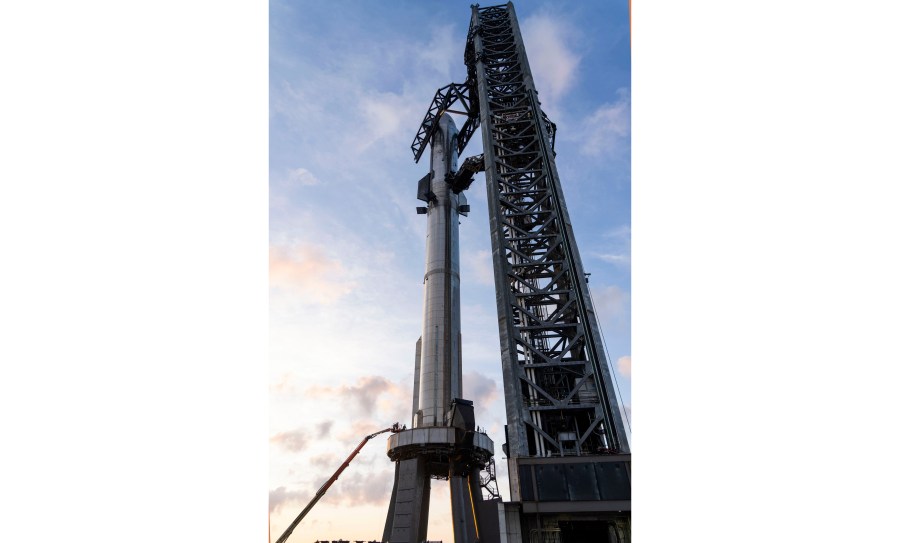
468, 4, 629, 457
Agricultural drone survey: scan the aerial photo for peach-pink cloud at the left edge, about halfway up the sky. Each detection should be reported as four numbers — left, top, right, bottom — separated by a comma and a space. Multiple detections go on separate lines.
269, 243, 355, 305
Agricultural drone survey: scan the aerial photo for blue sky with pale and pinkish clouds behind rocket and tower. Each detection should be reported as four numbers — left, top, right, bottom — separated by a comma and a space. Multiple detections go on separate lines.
269, 1, 631, 541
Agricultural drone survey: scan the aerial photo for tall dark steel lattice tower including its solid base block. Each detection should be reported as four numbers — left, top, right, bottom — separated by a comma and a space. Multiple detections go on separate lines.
465, 3, 631, 541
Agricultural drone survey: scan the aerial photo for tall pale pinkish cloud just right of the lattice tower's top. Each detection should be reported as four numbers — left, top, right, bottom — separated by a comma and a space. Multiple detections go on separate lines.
521, 13, 581, 113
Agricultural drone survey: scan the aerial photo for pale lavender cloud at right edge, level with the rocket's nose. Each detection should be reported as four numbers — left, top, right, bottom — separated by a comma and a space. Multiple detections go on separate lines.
580, 89, 631, 159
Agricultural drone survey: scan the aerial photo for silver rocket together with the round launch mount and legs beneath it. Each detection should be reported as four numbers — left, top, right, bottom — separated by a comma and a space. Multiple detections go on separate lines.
382, 114, 496, 543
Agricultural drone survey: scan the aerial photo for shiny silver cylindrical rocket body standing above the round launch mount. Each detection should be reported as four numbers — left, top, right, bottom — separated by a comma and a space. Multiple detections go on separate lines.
414, 115, 462, 427
